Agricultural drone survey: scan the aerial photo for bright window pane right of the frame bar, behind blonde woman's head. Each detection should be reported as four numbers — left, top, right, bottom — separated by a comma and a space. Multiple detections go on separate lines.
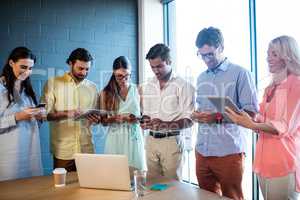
256, 0, 300, 96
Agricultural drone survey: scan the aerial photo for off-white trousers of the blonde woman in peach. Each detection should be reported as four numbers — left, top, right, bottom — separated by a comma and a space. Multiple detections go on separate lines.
257, 173, 298, 200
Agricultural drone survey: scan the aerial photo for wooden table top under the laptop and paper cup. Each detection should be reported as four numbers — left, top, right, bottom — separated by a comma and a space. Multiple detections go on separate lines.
0, 173, 232, 200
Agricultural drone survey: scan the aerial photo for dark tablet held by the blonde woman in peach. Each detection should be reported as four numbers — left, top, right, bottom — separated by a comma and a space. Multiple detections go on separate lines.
207, 96, 241, 123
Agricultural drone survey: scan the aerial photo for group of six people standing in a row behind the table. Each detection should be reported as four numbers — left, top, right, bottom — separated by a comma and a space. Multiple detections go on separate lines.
0, 27, 300, 200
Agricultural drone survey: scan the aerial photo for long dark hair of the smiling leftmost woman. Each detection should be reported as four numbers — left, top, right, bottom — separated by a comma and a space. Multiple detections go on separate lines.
1, 47, 37, 107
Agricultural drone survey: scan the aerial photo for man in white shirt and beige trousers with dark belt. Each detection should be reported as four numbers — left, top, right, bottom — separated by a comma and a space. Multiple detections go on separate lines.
141, 44, 195, 179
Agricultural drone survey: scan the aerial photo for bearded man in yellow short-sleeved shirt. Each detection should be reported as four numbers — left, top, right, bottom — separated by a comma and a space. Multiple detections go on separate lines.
41, 48, 97, 171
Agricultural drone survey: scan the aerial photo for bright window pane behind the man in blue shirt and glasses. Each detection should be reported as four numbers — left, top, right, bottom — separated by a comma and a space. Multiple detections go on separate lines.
176, 0, 252, 199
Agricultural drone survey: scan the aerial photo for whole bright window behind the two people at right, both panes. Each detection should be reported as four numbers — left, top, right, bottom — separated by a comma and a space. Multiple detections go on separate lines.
165, 0, 300, 199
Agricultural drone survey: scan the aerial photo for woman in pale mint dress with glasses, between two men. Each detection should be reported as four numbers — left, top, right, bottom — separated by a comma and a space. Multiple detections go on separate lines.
100, 56, 145, 172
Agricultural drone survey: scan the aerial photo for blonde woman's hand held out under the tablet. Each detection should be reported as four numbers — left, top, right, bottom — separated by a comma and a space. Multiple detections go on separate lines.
225, 107, 254, 129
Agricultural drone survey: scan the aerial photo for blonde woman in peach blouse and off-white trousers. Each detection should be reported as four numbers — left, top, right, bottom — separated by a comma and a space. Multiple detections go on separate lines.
226, 36, 300, 200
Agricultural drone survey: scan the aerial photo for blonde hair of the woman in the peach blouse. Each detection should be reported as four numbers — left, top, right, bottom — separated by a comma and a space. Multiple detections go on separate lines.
269, 35, 300, 82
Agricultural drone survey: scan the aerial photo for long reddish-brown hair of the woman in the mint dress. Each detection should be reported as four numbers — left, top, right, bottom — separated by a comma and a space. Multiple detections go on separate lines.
100, 56, 131, 111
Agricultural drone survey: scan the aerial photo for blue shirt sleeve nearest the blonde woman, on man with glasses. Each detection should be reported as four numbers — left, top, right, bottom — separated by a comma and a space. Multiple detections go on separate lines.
237, 71, 258, 113
